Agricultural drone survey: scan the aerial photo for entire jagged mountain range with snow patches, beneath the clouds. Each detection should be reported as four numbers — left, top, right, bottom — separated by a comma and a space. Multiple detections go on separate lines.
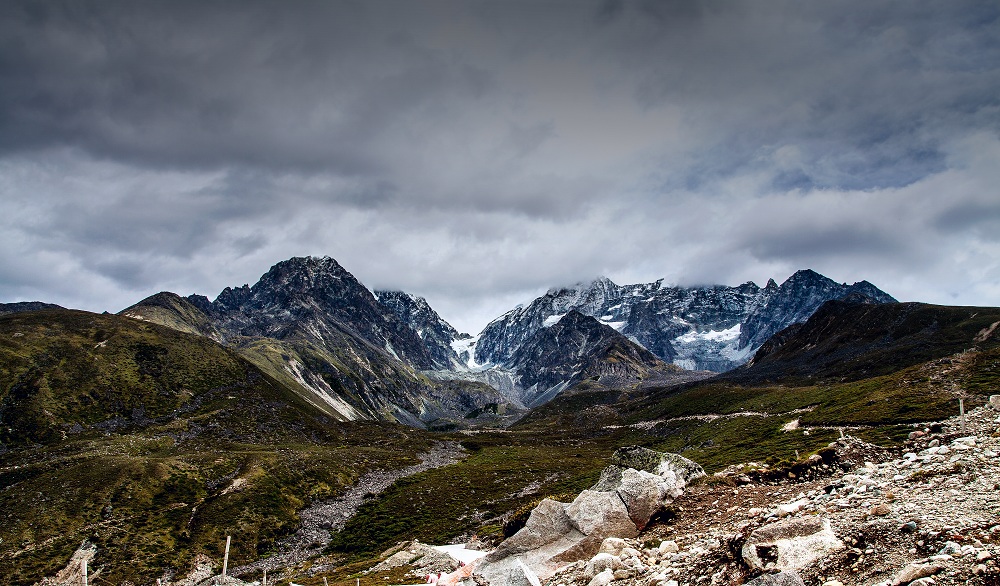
13, 257, 895, 429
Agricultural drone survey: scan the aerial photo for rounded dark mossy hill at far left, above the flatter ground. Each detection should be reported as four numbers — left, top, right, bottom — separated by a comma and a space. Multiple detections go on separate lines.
0, 310, 338, 445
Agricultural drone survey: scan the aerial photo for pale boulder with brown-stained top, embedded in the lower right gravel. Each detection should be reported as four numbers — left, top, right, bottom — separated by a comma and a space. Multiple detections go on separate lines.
742, 517, 846, 571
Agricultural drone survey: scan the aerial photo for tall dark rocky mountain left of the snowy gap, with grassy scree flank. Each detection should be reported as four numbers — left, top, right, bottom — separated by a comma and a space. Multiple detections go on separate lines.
122, 258, 509, 427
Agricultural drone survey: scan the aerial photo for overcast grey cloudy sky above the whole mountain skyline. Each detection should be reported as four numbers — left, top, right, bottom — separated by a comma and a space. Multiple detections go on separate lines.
0, 0, 1000, 333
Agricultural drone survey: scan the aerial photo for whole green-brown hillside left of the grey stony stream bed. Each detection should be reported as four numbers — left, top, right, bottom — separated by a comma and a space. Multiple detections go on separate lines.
0, 311, 429, 584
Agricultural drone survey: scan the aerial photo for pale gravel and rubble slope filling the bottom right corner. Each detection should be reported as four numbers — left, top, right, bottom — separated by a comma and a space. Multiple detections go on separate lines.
380, 397, 1000, 586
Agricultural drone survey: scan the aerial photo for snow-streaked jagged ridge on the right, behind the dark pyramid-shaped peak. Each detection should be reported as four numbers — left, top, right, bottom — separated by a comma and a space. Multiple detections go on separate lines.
475, 270, 895, 372
